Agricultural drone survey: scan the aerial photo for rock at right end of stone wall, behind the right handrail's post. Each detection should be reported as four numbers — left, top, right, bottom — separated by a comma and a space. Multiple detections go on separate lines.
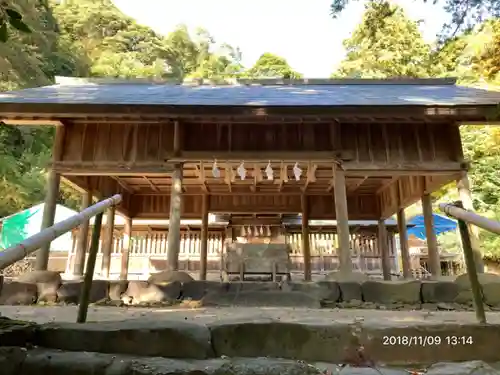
455, 273, 500, 306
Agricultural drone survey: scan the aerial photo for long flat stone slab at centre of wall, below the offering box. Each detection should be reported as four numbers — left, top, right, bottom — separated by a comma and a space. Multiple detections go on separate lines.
202, 290, 321, 309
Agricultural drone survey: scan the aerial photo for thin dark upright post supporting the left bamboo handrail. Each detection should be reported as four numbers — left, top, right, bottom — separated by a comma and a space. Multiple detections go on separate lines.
76, 212, 103, 323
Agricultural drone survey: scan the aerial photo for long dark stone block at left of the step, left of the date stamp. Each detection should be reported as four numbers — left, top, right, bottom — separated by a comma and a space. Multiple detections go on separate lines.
36, 320, 213, 359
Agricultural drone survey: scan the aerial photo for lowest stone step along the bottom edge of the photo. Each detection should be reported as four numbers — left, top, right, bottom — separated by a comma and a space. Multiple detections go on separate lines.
0, 347, 500, 375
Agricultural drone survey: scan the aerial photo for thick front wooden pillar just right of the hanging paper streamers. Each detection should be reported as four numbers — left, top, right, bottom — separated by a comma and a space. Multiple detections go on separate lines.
334, 169, 352, 273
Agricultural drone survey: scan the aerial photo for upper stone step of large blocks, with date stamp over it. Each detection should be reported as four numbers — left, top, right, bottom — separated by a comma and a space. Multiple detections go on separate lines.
0, 319, 500, 365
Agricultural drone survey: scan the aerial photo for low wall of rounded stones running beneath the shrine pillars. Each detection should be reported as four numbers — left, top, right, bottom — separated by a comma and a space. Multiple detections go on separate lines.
0, 274, 500, 310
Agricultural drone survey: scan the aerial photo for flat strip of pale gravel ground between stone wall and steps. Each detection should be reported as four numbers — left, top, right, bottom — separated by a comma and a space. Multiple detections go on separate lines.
0, 306, 500, 326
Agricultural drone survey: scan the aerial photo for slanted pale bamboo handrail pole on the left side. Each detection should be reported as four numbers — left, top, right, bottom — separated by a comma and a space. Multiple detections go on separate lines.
0, 194, 122, 269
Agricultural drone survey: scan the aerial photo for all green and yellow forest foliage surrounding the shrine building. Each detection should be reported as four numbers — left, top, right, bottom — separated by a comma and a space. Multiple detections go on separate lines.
0, 0, 500, 256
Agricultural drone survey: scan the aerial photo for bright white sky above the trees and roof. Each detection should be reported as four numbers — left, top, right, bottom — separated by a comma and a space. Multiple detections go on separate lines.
114, 0, 447, 78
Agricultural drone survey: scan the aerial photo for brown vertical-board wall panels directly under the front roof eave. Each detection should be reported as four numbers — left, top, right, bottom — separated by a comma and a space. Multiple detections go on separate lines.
62, 123, 462, 166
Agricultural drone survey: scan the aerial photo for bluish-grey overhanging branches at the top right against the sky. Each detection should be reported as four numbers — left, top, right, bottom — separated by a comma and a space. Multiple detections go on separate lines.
330, 0, 500, 37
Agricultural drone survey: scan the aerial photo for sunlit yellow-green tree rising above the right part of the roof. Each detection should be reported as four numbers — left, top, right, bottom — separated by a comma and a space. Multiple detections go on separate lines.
333, 0, 430, 78
